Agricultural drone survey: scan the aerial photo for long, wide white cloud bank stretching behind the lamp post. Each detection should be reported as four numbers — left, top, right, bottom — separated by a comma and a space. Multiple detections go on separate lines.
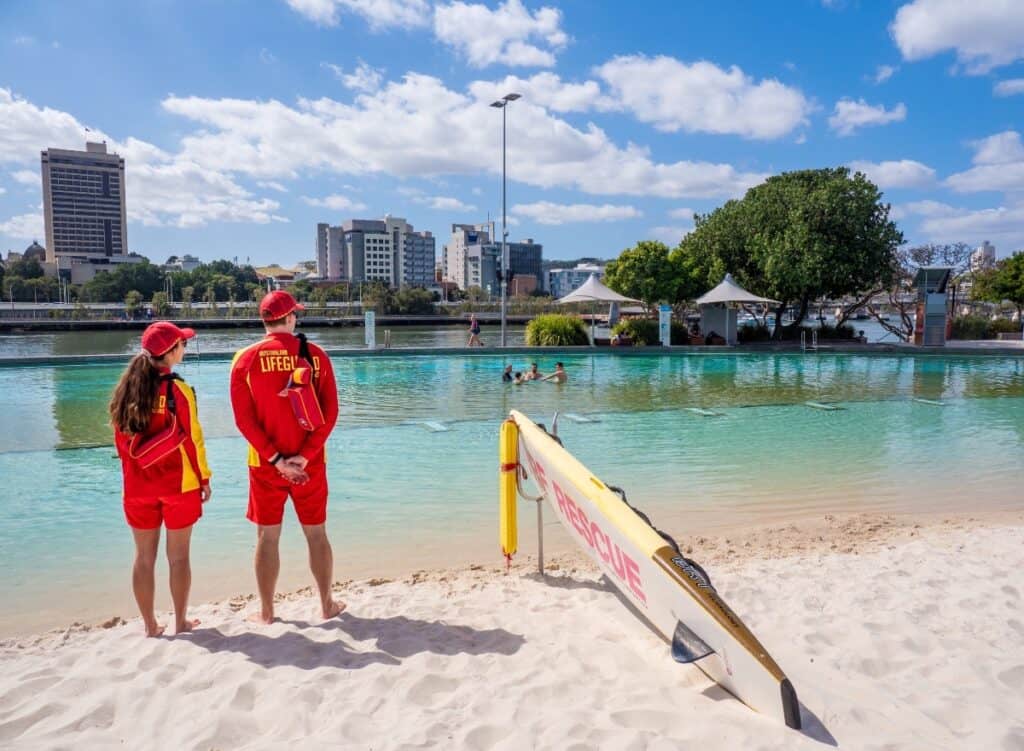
163, 73, 766, 198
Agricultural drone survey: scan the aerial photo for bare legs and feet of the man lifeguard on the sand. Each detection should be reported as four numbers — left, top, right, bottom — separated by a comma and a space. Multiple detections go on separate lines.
250, 525, 345, 623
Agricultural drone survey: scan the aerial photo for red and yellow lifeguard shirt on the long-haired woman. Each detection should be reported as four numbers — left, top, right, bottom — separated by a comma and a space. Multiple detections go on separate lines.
114, 368, 211, 498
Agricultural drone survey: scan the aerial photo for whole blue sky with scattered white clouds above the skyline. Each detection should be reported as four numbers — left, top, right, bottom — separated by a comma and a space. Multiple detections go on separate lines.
0, 0, 1024, 265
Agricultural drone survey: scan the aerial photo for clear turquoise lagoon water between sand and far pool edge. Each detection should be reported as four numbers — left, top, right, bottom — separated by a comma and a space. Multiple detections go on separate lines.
0, 354, 1024, 633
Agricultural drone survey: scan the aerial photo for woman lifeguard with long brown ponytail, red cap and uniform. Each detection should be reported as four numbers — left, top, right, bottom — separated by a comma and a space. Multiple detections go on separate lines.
110, 321, 210, 636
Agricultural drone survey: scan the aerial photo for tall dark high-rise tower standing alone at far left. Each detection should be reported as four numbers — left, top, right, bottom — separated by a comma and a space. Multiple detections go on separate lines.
42, 142, 128, 267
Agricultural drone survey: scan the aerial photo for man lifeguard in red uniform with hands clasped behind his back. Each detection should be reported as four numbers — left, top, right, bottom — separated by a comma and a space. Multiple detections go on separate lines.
230, 290, 345, 624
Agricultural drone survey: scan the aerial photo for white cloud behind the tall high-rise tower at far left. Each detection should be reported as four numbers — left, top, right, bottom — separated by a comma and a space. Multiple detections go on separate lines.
0, 88, 279, 227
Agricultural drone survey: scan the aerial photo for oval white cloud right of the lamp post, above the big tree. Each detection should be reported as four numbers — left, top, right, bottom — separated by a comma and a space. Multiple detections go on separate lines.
595, 55, 812, 138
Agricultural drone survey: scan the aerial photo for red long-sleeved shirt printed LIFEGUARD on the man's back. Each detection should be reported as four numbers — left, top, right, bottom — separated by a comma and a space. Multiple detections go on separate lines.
231, 332, 338, 467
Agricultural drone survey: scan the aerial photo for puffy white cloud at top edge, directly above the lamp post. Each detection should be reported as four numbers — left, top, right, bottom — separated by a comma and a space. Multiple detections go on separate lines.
434, 0, 568, 68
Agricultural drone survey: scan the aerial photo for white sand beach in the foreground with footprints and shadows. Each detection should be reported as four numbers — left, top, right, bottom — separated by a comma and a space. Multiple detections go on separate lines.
0, 512, 1024, 751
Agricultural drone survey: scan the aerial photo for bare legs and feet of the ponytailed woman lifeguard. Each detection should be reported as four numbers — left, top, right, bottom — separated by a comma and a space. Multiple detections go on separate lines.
131, 527, 199, 636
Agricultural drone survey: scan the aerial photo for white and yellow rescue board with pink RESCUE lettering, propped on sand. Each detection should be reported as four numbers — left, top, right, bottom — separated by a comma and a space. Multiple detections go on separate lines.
502, 410, 800, 728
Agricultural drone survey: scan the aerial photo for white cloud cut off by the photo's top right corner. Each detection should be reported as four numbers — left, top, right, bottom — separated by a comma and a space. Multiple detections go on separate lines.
889, 0, 1024, 75
